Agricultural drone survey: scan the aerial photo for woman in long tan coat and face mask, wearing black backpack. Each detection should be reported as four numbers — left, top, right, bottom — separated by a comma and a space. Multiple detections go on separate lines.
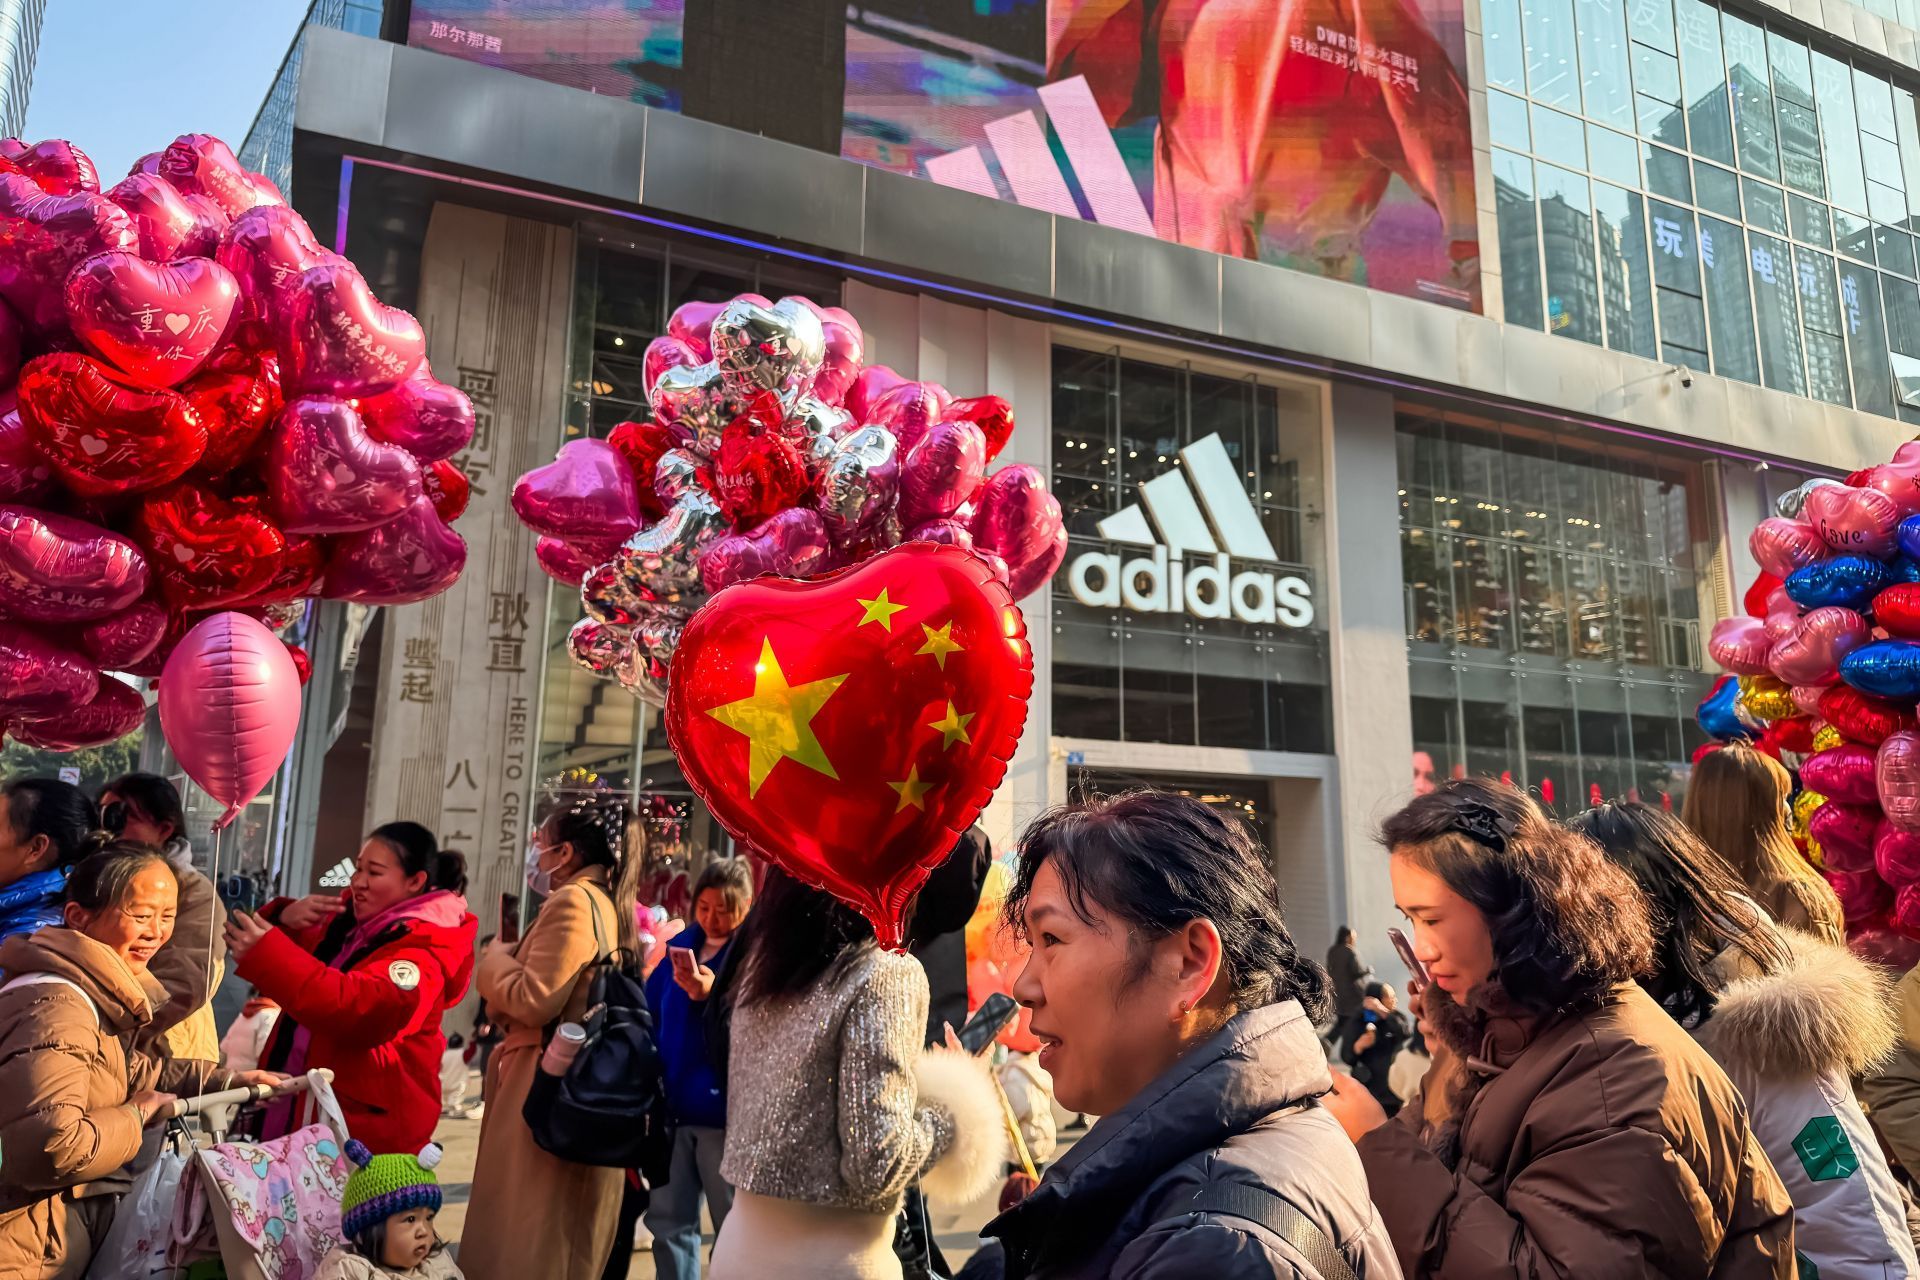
459, 794, 641, 1280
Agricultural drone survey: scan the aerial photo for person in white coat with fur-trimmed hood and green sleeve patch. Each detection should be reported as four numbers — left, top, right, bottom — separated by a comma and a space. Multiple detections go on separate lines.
1567, 804, 1920, 1280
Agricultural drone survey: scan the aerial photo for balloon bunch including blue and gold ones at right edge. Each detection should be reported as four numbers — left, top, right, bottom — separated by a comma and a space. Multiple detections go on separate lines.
1699, 441, 1920, 952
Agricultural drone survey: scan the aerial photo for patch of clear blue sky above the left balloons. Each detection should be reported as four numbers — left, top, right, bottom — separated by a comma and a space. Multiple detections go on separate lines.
27, 0, 307, 186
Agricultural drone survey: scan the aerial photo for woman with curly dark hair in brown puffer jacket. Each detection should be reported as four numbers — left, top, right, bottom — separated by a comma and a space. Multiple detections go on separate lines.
1327, 781, 1795, 1280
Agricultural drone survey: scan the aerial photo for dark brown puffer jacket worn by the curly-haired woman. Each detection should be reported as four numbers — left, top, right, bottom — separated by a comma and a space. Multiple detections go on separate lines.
1359, 984, 1795, 1280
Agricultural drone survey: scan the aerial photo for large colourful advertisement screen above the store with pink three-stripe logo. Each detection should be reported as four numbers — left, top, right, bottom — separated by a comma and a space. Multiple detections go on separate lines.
409, 0, 1480, 311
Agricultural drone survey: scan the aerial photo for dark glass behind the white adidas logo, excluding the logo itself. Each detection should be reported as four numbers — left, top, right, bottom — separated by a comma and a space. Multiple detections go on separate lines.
1052, 345, 1332, 752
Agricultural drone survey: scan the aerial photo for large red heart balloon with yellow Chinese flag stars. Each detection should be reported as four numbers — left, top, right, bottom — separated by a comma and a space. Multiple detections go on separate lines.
666, 543, 1033, 950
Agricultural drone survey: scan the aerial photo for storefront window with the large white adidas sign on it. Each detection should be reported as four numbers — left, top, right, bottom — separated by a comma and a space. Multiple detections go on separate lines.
1052, 345, 1331, 752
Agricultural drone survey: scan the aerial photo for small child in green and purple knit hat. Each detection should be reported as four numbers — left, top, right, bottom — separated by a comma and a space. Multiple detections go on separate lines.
313, 1138, 461, 1280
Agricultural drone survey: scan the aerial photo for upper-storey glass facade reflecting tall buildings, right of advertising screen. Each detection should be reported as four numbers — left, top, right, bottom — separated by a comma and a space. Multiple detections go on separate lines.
1482, 0, 1920, 422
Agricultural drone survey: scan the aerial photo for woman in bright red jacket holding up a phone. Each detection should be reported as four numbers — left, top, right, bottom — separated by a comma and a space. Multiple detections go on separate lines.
227, 821, 474, 1155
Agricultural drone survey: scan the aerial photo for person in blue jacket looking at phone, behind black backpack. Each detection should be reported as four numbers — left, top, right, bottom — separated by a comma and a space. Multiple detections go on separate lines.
629, 858, 753, 1280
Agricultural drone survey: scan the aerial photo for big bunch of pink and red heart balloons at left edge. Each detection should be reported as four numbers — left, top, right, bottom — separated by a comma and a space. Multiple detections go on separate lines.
0, 134, 474, 750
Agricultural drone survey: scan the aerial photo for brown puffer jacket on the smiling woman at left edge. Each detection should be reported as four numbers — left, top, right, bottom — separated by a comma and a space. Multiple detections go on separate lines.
0, 927, 207, 1276
